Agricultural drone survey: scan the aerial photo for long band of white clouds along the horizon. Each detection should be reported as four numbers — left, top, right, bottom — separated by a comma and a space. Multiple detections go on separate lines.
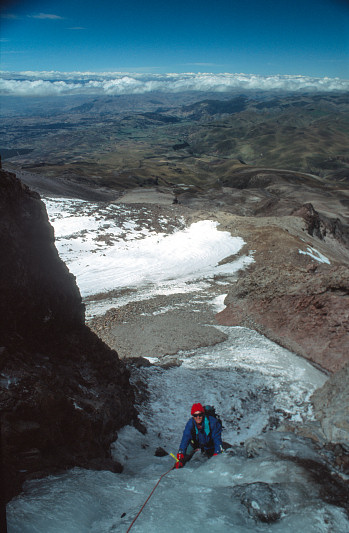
0, 71, 349, 96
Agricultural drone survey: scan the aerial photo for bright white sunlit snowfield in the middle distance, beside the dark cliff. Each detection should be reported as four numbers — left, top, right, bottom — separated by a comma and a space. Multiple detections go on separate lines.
46, 200, 253, 312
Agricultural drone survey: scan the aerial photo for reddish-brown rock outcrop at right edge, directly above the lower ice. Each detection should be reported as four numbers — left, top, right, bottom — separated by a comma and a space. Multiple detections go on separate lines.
219, 265, 349, 372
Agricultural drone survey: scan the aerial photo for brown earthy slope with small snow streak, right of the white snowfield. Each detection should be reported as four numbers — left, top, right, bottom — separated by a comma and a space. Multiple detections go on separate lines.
217, 206, 349, 372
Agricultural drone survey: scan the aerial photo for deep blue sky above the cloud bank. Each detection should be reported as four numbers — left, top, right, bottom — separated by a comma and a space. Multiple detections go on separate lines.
1, 0, 349, 79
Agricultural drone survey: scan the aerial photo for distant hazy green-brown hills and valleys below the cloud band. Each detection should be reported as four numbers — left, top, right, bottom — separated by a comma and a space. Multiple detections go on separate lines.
0, 91, 349, 189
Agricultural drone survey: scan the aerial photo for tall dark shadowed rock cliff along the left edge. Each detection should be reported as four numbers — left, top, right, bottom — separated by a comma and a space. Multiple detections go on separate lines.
0, 170, 137, 499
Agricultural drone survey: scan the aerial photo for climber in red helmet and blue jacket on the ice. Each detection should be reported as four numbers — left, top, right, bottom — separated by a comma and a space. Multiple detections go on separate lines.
176, 403, 223, 468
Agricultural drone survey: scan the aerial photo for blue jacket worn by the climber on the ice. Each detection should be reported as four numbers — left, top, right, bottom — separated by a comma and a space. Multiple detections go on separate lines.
178, 416, 222, 455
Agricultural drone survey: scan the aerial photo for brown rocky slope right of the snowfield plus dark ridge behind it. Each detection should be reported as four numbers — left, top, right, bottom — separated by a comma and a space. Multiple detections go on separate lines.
174, 169, 349, 372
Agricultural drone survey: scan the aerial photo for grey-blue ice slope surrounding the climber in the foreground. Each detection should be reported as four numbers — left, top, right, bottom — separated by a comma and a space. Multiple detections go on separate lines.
8, 328, 349, 533
